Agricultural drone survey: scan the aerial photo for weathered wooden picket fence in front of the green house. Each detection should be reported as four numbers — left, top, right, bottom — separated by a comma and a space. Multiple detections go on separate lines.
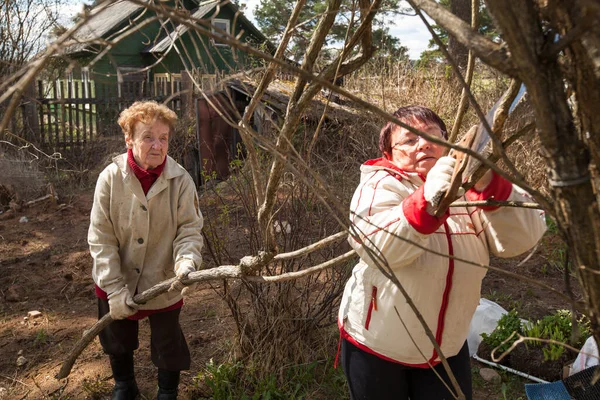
22, 80, 186, 152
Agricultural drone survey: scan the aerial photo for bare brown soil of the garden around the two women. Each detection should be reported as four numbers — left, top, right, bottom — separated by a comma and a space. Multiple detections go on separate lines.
0, 191, 580, 399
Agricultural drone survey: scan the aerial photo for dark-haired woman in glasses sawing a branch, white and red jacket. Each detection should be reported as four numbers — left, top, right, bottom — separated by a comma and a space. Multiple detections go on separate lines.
338, 106, 546, 400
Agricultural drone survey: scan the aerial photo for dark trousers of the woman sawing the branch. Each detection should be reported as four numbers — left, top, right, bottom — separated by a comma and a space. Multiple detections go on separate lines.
342, 340, 472, 400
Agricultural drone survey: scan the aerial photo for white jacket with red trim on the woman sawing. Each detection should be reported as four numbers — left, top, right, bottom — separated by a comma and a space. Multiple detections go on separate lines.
338, 159, 546, 368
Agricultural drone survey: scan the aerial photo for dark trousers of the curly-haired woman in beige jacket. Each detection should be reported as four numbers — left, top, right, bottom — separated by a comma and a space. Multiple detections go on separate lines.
98, 299, 191, 371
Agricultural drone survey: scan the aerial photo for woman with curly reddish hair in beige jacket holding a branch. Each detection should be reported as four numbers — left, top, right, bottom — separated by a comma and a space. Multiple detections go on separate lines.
88, 101, 203, 400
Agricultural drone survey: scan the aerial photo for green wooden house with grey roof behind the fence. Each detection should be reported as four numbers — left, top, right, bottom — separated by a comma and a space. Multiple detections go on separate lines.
64, 0, 273, 94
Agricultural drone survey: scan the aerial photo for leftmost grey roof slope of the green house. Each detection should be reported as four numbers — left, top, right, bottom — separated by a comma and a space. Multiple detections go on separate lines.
65, 0, 144, 53
